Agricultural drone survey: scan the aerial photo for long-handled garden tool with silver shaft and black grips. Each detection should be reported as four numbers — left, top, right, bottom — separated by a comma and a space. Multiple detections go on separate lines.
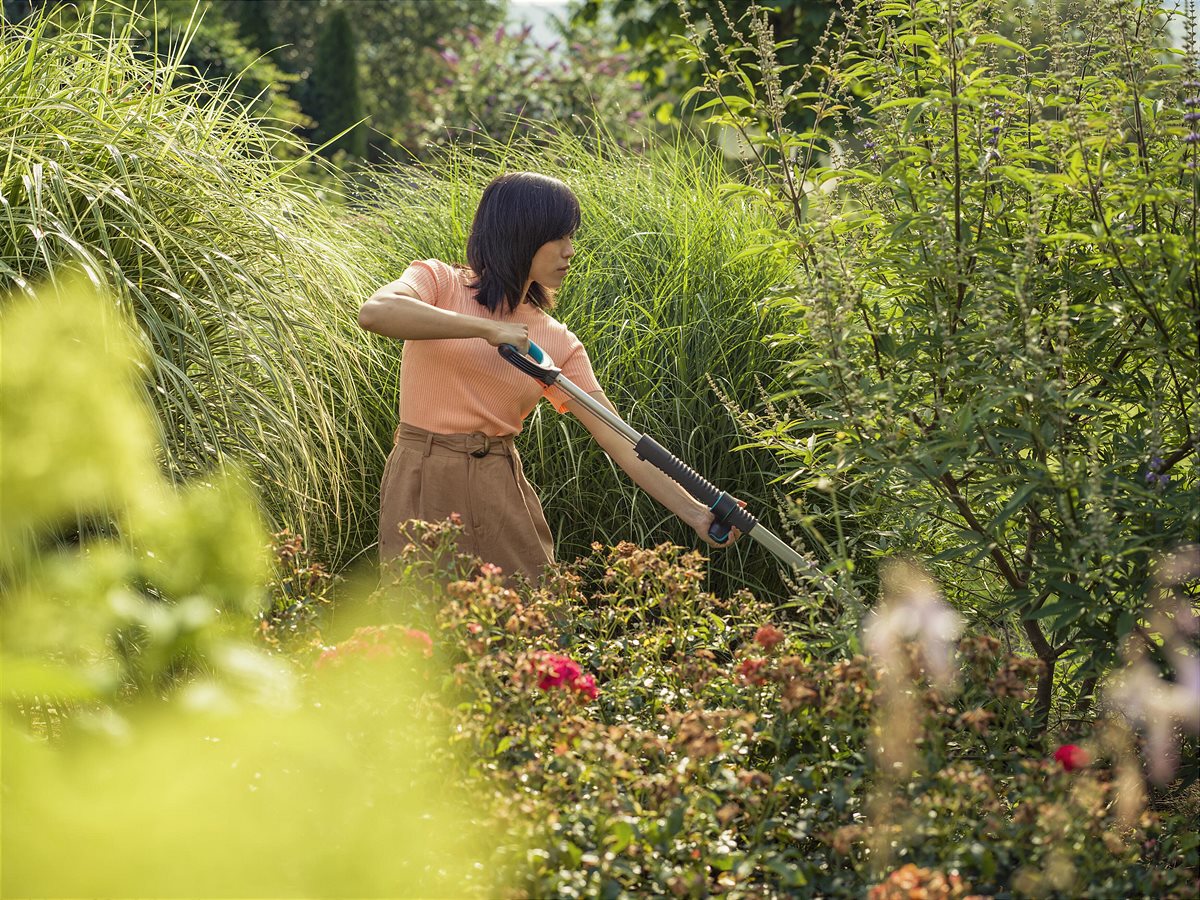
498, 341, 811, 569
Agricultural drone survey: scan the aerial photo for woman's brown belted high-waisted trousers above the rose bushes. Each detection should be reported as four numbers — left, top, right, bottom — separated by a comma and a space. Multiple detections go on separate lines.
379, 422, 554, 582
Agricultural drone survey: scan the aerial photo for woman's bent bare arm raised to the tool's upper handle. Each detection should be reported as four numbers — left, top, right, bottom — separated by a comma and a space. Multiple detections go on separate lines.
359, 281, 529, 352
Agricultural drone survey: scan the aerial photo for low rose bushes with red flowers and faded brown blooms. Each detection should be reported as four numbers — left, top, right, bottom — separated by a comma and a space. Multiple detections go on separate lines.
367, 523, 1200, 898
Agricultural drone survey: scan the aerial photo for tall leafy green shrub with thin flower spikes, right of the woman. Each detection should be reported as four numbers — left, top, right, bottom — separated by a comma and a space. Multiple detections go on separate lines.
692, 0, 1200, 725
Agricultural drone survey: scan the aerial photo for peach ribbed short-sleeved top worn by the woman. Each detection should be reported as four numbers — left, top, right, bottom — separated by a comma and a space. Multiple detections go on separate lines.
400, 259, 600, 437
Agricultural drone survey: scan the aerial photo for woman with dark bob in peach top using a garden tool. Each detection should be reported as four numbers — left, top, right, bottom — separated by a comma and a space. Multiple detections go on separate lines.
359, 172, 738, 580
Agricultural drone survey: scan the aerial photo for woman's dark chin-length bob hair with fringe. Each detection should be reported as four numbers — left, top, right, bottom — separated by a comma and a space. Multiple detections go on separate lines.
467, 172, 580, 312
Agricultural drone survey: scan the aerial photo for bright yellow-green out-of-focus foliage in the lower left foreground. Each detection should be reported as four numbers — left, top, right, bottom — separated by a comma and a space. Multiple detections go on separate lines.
0, 278, 494, 896
